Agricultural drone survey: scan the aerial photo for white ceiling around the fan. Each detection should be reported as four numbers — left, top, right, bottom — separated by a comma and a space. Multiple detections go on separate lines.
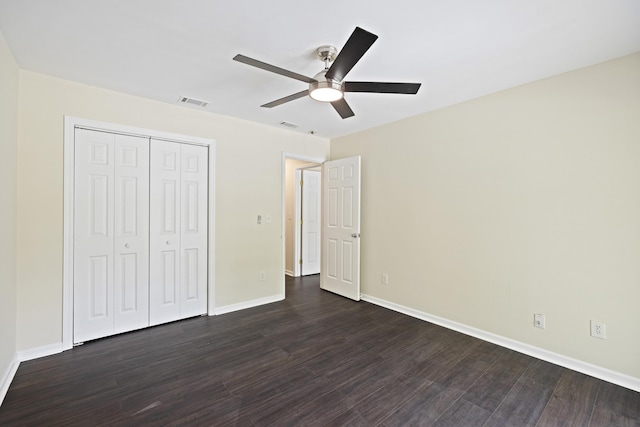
0, 0, 640, 138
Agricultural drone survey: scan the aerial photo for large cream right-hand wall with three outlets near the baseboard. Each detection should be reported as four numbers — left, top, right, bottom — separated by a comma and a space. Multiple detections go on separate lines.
331, 54, 640, 378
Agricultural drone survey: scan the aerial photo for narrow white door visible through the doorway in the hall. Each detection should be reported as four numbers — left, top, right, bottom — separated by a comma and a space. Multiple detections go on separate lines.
300, 169, 322, 276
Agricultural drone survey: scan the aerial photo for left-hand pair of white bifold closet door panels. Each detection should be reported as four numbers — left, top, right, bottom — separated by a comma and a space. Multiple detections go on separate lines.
73, 129, 149, 342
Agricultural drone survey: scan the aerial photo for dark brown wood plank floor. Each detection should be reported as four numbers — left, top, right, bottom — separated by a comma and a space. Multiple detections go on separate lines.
0, 276, 640, 427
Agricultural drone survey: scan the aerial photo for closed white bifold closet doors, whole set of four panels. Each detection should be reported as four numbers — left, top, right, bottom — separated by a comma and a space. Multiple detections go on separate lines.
73, 128, 209, 343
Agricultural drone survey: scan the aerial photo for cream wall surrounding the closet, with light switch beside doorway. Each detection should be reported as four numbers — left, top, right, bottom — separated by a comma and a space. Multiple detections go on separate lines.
17, 71, 329, 350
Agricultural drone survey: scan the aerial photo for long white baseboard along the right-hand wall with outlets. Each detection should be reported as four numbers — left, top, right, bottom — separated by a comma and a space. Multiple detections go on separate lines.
361, 294, 640, 392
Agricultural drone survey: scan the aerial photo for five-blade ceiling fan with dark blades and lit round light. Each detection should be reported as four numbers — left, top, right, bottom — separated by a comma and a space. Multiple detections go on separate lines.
233, 27, 420, 119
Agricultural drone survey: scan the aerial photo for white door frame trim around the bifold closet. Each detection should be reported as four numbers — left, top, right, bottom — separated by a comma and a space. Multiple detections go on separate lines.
62, 116, 216, 351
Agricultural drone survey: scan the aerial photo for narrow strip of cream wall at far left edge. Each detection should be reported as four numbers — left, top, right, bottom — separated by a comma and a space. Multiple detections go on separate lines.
0, 32, 19, 390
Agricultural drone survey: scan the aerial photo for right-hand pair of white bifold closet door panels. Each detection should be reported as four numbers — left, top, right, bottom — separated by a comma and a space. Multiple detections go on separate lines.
149, 139, 208, 325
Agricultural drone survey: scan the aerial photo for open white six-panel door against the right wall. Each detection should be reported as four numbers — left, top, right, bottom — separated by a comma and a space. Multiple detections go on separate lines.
320, 156, 360, 301
